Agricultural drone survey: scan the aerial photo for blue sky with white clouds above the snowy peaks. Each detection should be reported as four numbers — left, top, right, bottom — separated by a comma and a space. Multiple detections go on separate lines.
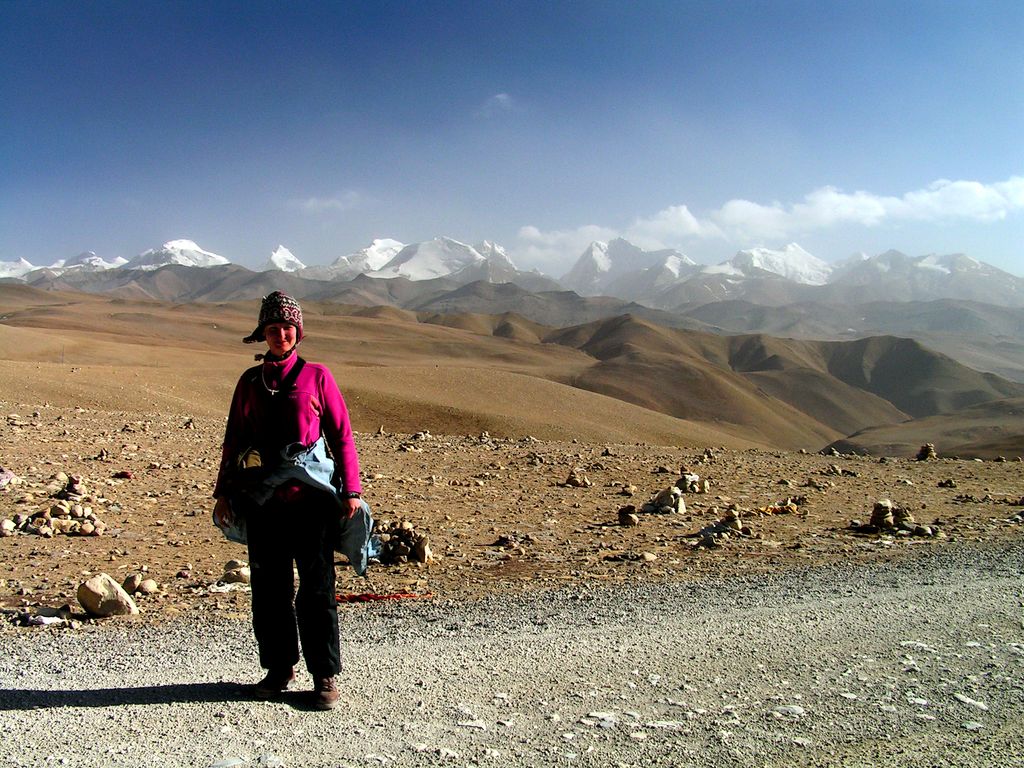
0, 0, 1024, 276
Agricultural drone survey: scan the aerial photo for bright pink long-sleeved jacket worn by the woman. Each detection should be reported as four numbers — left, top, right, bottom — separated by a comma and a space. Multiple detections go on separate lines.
213, 354, 362, 497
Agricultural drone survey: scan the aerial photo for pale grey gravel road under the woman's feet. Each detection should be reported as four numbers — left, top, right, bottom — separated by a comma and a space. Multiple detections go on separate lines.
0, 546, 1024, 768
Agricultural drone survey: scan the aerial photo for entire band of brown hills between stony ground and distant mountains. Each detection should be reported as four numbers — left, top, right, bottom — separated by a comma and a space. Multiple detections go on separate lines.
0, 288, 1024, 456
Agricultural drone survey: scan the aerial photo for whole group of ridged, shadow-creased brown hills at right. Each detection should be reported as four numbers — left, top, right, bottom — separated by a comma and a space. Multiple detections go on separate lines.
545, 316, 1024, 446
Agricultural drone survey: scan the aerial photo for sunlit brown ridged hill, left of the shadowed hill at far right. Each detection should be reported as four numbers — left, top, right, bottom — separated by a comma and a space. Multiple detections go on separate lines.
546, 317, 906, 447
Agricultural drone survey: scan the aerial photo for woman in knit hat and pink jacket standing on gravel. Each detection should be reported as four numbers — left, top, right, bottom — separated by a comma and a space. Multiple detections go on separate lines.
214, 291, 369, 710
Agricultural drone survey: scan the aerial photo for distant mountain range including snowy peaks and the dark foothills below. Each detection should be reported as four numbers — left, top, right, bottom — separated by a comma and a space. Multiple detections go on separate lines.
8, 238, 1024, 381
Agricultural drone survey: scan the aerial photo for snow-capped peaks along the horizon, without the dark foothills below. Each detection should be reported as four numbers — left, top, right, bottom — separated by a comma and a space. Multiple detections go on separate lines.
6, 238, 1024, 312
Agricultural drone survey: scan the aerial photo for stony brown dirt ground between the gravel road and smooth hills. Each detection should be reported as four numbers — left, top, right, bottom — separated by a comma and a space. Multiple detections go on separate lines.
0, 400, 1024, 621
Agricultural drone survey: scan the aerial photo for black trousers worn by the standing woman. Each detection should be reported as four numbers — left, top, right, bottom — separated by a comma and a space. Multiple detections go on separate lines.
247, 492, 341, 678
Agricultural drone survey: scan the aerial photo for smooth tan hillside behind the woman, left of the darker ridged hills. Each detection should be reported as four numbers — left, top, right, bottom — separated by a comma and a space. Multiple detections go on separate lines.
0, 287, 754, 447
